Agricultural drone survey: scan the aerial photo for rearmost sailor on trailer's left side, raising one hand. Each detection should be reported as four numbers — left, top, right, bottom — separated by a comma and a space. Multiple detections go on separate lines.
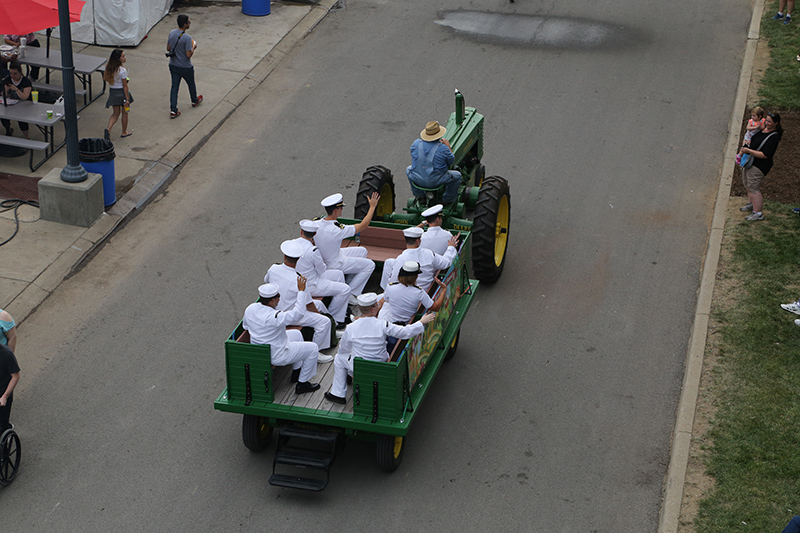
242, 277, 319, 394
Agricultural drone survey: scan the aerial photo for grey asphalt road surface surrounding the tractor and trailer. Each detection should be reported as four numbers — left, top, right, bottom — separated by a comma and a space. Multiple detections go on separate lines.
0, 0, 750, 532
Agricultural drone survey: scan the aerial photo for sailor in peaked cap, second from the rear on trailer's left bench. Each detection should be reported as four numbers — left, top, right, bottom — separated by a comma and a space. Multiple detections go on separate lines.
264, 241, 333, 363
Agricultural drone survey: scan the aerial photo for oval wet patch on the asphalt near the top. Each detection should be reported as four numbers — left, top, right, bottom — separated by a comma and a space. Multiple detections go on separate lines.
436, 11, 634, 49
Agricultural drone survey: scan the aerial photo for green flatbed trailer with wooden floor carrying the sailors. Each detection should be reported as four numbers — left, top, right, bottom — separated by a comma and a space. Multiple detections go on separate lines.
214, 219, 479, 490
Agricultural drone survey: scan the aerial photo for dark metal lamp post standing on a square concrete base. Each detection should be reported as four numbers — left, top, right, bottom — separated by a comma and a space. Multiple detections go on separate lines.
58, 0, 88, 183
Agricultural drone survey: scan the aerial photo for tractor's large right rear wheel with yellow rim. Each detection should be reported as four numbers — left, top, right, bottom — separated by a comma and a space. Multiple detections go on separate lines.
472, 176, 511, 283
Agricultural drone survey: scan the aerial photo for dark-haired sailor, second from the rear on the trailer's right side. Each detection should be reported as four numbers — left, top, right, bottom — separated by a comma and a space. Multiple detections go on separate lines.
378, 261, 447, 324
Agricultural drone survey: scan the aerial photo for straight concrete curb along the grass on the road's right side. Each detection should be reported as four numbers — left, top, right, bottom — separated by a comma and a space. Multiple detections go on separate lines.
658, 0, 764, 533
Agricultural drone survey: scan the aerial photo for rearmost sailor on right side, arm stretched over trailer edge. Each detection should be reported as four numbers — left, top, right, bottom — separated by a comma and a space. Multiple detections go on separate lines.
325, 292, 435, 404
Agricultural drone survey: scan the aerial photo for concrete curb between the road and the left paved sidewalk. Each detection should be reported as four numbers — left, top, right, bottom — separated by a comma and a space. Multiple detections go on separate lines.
5, 0, 339, 324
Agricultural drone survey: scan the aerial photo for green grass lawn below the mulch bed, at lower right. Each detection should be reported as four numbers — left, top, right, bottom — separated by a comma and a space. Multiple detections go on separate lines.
695, 202, 800, 533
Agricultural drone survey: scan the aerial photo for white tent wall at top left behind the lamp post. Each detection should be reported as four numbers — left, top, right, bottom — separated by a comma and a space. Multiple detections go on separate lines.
53, 0, 172, 46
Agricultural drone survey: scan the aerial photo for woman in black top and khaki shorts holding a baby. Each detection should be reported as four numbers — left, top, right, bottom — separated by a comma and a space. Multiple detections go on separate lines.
739, 113, 783, 222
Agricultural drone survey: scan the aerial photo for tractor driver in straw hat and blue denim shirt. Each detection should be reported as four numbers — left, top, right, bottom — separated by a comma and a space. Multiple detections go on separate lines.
406, 120, 461, 204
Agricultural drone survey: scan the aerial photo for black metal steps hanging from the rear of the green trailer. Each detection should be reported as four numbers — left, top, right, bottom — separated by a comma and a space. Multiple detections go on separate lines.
269, 425, 344, 491
